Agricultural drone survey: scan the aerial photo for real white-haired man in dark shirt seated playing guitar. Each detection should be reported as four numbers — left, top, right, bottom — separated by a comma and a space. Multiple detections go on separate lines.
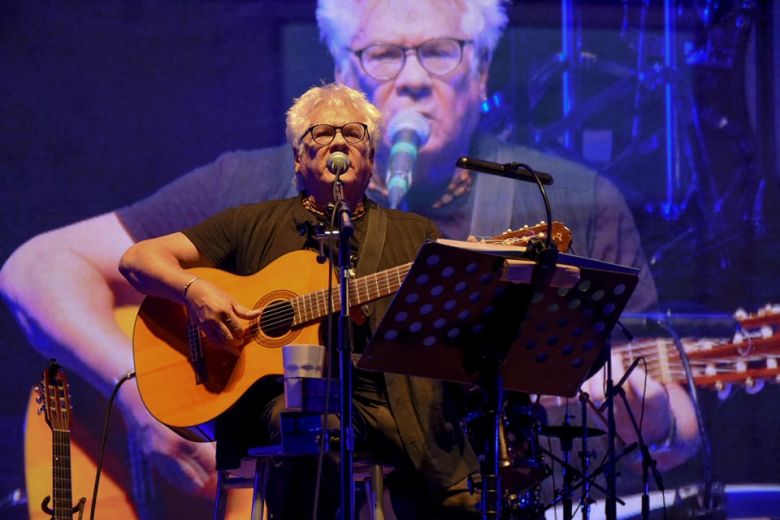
119, 85, 476, 518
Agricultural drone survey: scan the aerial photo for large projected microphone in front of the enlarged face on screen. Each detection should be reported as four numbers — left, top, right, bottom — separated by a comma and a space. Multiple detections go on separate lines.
385, 110, 431, 209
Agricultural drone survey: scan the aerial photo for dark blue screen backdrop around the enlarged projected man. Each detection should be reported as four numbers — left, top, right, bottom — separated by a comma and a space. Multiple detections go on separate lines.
0, 0, 780, 517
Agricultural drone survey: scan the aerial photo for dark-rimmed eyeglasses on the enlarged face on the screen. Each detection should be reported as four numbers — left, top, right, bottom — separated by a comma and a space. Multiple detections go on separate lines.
352, 38, 472, 81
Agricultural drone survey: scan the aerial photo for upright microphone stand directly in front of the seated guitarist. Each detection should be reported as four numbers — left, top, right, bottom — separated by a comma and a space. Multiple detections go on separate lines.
333, 173, 355, 520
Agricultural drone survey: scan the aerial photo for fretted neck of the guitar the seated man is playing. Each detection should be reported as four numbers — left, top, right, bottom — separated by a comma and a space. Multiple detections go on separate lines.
290, 262, 412, 326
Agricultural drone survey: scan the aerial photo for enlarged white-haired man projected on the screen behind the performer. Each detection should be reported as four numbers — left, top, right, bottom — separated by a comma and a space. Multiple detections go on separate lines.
0, 0, 697, 516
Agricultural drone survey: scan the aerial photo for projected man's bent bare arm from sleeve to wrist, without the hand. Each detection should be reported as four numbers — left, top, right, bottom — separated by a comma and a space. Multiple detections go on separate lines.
0, 213, 140, 395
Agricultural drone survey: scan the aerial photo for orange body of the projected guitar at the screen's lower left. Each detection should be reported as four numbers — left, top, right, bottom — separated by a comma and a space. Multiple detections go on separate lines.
24, 306, 252, 520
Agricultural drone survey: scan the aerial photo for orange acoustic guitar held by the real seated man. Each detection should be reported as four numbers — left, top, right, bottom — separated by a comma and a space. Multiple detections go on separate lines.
133, 222, 571, 430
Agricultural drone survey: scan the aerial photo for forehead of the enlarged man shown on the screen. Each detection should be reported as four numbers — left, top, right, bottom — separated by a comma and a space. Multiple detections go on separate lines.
350, 0, 468, 47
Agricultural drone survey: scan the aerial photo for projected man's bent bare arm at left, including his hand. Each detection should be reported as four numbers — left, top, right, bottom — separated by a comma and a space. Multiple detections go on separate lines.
0, 213, 214, 492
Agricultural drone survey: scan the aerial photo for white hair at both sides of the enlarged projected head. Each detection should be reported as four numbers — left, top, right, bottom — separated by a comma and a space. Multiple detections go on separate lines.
317, 0, 509, 66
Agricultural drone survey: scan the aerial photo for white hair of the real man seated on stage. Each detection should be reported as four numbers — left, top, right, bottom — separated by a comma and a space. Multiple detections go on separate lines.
285, 83, 382, 150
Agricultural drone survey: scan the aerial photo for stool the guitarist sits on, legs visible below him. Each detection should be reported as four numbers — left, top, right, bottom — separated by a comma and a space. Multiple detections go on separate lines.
213, 444, 385, 520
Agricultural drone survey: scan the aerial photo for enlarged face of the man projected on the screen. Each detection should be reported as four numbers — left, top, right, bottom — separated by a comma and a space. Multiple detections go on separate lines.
337, 0, 487, 169
